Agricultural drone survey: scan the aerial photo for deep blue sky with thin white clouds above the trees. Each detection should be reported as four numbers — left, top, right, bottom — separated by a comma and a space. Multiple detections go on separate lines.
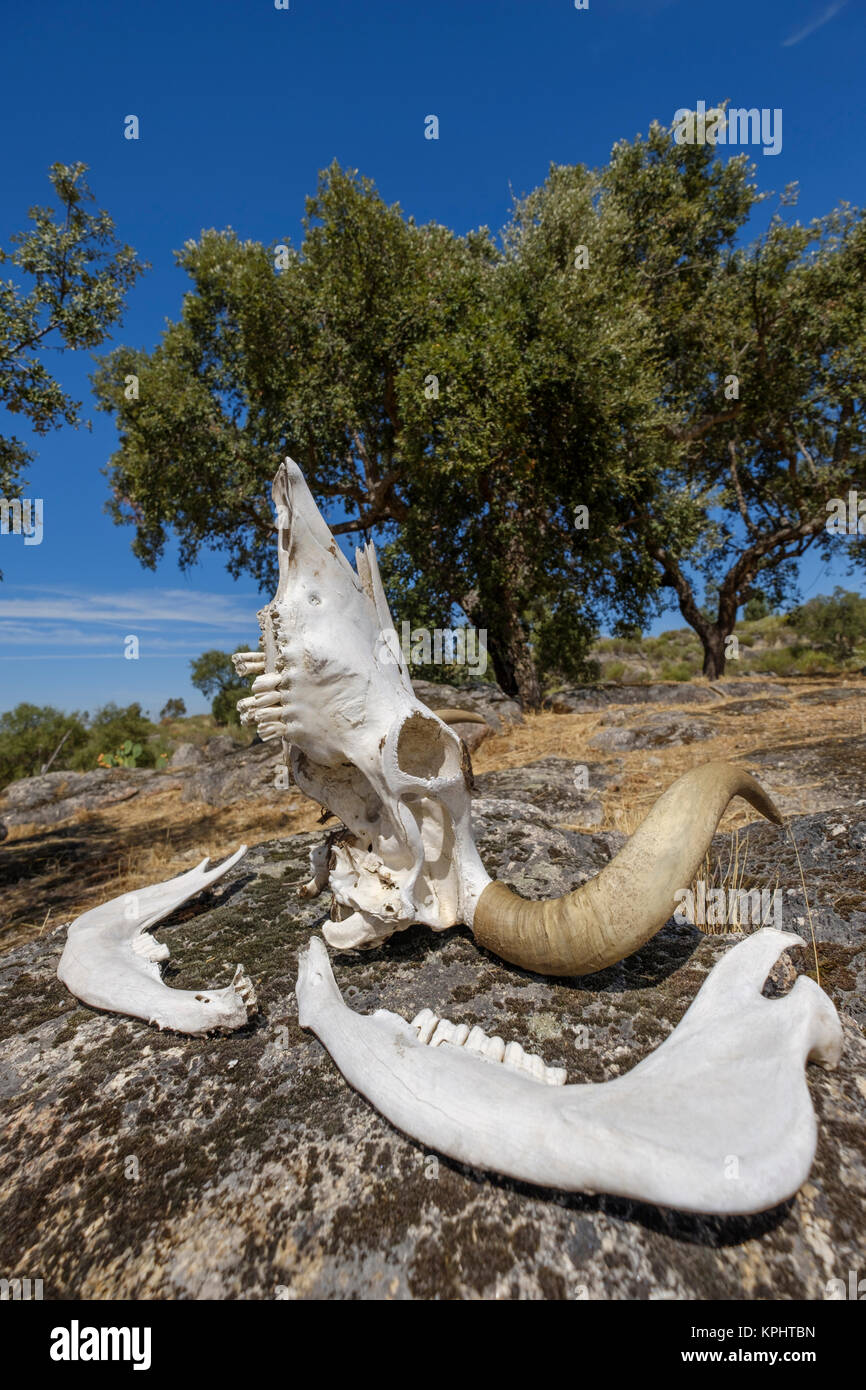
0, 0, 866, 713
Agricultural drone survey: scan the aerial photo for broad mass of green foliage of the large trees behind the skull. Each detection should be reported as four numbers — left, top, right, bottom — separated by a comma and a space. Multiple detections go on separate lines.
95, 124, 866, 695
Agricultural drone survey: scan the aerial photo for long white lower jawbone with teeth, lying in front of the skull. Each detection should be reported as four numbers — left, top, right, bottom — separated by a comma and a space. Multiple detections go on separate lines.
296, 927, 841, 1215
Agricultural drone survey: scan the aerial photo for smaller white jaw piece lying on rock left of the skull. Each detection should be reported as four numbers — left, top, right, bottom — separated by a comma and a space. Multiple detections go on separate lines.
57, 845, 256, 1034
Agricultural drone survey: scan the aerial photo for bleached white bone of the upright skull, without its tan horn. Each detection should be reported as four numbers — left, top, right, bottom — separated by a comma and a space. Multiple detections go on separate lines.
235, 460, 489, 949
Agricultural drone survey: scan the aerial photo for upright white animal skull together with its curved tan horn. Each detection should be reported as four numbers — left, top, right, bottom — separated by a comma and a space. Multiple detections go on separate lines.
235, 459, 781, 974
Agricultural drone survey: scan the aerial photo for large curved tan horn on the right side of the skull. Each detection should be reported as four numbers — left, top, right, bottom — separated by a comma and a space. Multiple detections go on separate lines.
473, 762, 783, 974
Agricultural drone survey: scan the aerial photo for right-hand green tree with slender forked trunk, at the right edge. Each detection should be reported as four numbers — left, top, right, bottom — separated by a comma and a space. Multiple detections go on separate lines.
594, 116, 866, 678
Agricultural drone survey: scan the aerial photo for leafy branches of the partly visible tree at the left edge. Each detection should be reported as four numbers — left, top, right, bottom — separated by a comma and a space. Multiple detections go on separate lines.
0, 164, 145, 522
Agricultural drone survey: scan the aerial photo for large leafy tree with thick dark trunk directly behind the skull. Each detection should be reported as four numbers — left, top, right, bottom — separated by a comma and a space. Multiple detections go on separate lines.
95, 165, 664, 705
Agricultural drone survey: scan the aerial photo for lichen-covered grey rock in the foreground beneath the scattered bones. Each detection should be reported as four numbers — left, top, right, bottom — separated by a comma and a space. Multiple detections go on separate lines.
0, 783, 866, 1300
